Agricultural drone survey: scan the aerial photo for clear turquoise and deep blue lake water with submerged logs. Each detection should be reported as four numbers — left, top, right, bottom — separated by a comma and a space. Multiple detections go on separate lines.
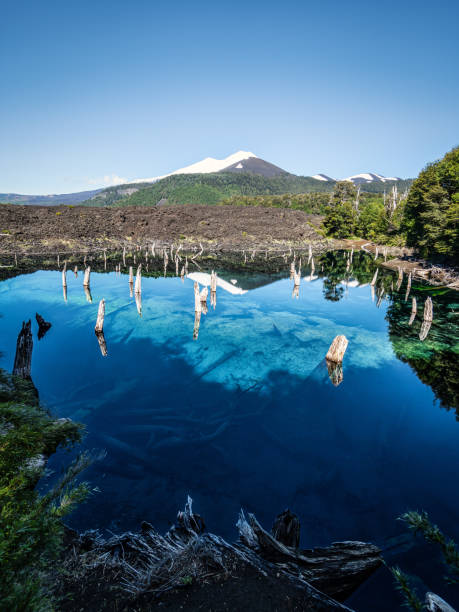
0, 255, 459, 610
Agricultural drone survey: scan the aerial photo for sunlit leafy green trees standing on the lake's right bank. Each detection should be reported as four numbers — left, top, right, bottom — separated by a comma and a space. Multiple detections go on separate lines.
324, 147, 459, 262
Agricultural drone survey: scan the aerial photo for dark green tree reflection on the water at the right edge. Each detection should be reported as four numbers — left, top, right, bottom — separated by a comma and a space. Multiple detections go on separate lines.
386, 285, 459, 420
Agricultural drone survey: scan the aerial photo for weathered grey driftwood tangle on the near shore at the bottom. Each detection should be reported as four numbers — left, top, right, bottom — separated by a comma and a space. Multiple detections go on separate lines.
72, 498, 381, 612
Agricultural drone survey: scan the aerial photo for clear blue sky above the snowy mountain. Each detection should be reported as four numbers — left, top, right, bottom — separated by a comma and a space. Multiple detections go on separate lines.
0, 0, 459, 194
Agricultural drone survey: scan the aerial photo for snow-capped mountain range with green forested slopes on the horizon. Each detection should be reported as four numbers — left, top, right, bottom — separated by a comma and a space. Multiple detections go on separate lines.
0, 151, 412, 206
